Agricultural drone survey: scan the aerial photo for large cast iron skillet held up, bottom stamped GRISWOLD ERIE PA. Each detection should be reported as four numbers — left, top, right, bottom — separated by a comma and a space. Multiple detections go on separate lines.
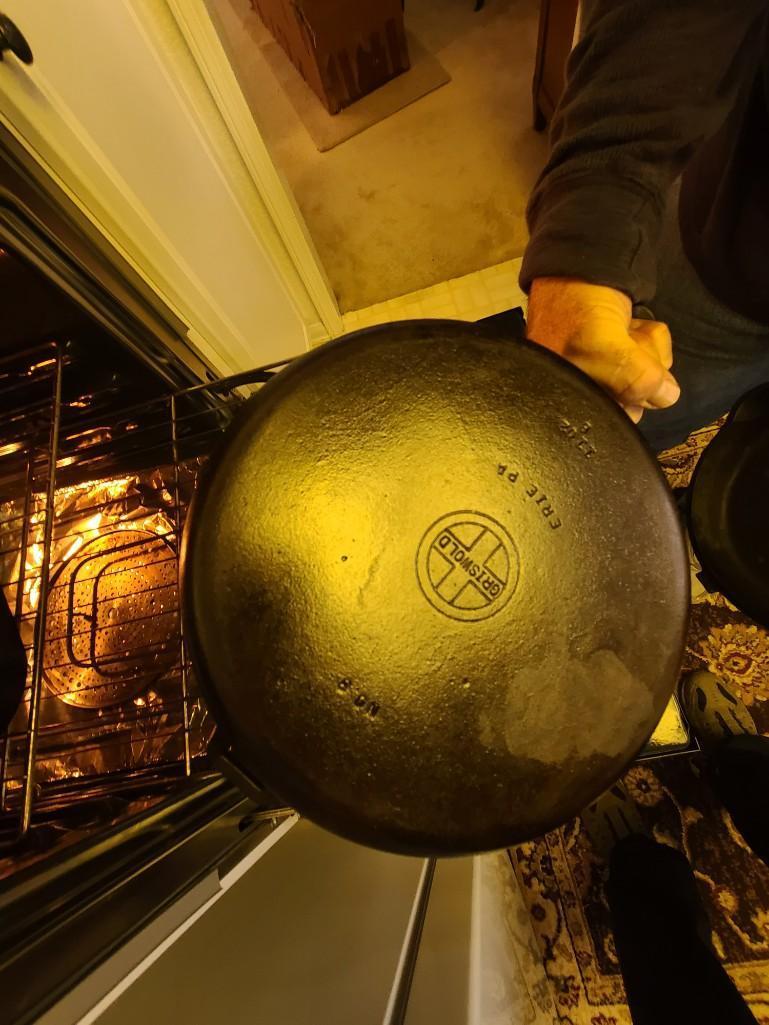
183, 321, 689, 854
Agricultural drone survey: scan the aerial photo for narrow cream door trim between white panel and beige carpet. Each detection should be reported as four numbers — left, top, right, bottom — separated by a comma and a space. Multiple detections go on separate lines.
165, 0, 343, 344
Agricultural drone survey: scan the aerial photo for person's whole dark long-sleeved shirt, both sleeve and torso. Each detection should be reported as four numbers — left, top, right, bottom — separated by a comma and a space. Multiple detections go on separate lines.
521, 0, 769, 324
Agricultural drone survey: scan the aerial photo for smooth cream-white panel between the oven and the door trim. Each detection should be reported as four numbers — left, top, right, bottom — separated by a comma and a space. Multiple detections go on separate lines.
0, 0, 318, 372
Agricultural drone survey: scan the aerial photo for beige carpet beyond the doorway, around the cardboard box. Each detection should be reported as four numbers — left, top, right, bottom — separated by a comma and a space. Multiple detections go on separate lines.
208, 0, 547, 312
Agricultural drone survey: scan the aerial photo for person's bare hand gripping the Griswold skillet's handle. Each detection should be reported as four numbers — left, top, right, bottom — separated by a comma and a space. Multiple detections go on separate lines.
526, 278, 681, 423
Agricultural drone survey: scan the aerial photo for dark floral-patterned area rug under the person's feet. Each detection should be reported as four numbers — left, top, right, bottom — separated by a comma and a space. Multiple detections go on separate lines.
509, 416, 769, 1025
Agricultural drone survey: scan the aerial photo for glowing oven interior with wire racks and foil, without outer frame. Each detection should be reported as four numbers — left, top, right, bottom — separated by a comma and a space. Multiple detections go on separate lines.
0, 237, 285, 879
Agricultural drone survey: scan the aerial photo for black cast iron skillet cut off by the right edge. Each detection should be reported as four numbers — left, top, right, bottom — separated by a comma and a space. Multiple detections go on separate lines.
688, 384, 769, 627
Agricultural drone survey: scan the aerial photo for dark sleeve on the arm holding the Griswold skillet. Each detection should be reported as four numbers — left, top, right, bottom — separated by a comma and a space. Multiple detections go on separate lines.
521, 0, 767, 302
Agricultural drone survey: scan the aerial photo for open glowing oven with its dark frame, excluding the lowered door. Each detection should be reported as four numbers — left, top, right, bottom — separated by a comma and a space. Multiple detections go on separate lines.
0, 117, 301, 1022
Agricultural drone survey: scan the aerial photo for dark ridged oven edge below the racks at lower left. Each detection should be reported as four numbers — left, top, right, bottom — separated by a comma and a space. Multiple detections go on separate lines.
0, 777, 291, 1025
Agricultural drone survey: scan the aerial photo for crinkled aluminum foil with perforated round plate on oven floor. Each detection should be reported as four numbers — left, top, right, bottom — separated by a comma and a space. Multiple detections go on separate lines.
0, 463, 214, 802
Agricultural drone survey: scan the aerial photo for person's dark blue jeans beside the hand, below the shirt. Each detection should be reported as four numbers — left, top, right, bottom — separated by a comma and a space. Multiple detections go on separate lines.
639, 189, 769, 452
